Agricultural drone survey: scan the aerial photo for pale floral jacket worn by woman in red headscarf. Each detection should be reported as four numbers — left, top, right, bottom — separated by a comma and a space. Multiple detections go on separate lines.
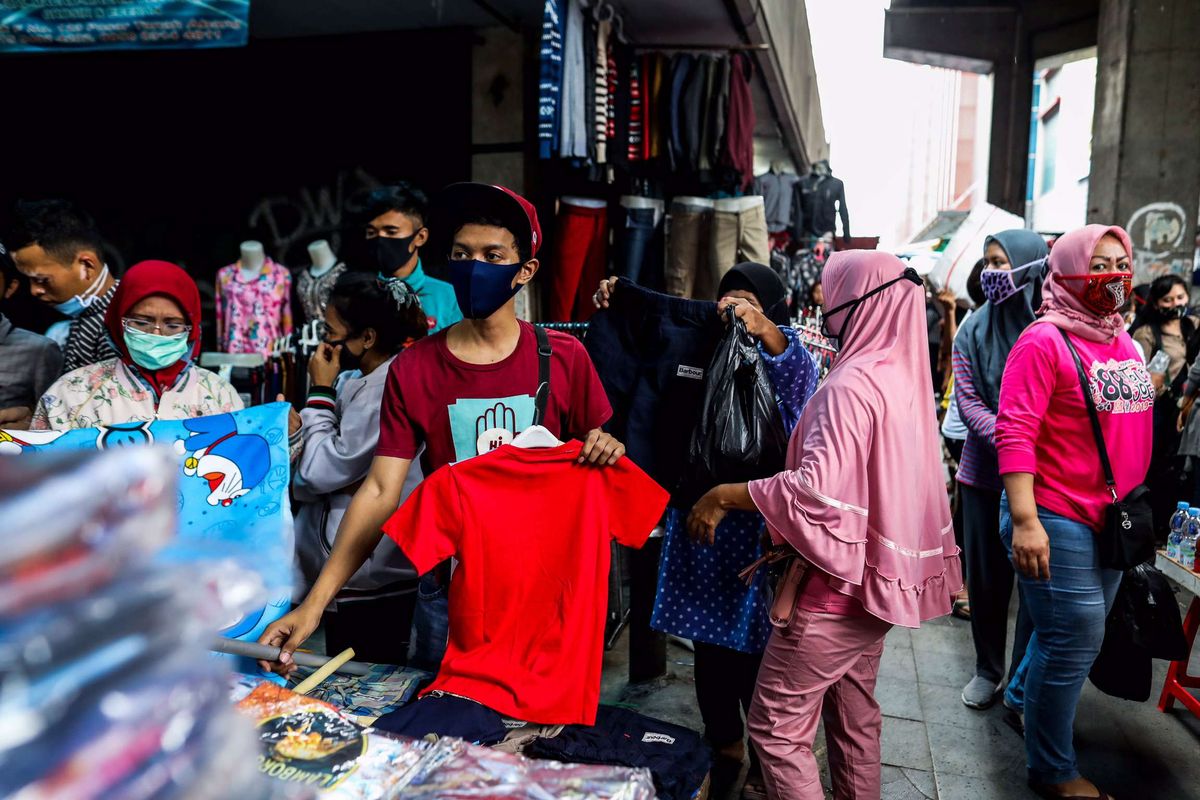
30, 359, 242, 431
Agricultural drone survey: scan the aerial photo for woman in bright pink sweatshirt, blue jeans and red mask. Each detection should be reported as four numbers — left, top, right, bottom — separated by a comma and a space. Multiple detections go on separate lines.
996, 225, 1156, 799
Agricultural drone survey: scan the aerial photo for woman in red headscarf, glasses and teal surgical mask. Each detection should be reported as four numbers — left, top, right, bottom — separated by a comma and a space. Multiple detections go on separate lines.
31, 261, 242, 431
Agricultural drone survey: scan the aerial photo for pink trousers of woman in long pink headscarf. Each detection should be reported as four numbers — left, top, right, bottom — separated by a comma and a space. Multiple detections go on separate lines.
749, 608, 892, 800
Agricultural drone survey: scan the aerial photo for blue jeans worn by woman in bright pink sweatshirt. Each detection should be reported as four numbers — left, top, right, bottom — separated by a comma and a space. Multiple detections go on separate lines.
1000, 497, 1121, 783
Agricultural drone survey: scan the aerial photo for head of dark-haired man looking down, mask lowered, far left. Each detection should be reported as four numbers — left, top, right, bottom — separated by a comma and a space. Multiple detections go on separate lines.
7, 200, 113, 305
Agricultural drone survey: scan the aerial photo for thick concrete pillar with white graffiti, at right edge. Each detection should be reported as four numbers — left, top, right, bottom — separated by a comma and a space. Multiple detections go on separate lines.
1087, 0, 1200, 283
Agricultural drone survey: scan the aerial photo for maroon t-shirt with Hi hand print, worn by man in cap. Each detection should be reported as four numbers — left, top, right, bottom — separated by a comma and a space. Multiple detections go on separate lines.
376, 321, 612, 474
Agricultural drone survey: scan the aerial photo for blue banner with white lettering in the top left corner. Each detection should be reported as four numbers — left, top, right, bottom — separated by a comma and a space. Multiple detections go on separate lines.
0, 0, 250, 53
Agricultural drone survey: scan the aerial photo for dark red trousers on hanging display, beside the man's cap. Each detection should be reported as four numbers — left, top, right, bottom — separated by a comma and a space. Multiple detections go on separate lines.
547, 198, 608, 323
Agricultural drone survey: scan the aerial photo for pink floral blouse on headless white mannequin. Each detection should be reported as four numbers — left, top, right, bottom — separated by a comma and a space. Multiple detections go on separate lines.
216, 258, 292, 356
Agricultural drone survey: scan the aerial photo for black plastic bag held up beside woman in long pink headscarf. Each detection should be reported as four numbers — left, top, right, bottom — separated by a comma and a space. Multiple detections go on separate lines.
689, 309, 787, 492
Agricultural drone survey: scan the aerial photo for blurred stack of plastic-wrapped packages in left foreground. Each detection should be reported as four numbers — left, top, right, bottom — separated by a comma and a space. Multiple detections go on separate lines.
0, 447, 288, 800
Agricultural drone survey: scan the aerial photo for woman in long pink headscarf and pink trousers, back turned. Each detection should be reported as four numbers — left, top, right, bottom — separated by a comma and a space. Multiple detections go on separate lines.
689, 251, 962, 800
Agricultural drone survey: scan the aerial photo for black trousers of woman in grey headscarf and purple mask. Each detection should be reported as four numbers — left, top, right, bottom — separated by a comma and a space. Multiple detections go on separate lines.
958, 483, 1033, 684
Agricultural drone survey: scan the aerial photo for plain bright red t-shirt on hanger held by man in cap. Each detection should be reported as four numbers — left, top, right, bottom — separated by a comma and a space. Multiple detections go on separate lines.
384, 441, 668, 724
